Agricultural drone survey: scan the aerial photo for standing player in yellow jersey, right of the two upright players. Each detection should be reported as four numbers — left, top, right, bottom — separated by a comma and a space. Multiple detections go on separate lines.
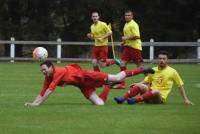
113, 10, 143, 88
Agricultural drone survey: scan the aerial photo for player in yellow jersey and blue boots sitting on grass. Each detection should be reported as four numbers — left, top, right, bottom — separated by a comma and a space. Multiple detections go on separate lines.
114, 51, 192, 105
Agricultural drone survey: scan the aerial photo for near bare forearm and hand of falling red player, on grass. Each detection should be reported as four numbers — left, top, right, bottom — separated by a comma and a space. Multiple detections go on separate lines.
24, 89, 52, 107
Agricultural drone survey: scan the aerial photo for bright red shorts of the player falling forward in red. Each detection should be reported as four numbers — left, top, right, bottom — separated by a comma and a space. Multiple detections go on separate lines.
80, 70, 108, 98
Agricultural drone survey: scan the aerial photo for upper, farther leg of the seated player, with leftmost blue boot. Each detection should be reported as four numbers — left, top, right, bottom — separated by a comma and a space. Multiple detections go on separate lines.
114, 83, 148, 104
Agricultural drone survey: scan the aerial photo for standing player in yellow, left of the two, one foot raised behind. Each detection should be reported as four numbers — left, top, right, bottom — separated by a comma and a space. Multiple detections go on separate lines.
87, 11, 120, 71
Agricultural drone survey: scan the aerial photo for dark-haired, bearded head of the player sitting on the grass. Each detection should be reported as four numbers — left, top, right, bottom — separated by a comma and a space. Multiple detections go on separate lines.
158, 51, 169, 68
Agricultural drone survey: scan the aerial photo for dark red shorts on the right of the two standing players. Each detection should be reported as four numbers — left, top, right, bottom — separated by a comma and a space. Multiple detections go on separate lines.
121, 46, 143, 64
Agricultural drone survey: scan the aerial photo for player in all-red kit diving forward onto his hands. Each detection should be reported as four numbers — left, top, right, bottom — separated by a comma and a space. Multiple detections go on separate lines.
25, 61, 154, 106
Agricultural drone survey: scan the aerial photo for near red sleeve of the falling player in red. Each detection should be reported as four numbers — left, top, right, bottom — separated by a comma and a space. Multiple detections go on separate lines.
49, 71, 65, 91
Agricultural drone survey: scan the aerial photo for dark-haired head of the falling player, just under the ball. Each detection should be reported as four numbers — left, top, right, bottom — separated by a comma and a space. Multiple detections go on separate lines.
40, 60, 54, 77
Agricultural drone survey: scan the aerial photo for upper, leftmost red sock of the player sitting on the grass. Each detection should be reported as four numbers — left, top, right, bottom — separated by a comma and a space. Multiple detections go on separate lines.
123, 86, 141, 100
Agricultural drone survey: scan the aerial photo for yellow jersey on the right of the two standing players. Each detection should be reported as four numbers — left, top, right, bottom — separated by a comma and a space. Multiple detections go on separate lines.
123, 20, 142, 50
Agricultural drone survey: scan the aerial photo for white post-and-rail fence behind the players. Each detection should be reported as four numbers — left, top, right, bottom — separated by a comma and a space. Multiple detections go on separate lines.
0, 37, 200, 63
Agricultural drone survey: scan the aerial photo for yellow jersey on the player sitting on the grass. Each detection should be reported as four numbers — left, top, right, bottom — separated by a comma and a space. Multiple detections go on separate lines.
144, 66, 184, 101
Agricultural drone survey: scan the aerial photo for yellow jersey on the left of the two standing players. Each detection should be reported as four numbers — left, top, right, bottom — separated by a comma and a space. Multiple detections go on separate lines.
91, 21, 112, 46
